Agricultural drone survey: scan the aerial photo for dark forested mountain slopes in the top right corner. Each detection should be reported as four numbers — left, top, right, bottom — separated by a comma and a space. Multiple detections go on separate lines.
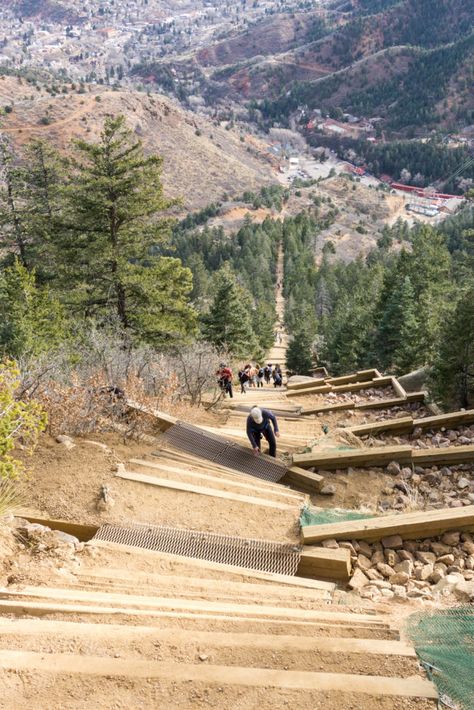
143, 0, 474, 135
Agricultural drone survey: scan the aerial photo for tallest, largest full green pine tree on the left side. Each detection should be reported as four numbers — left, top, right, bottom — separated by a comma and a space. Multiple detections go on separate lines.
56, 116, 196, 343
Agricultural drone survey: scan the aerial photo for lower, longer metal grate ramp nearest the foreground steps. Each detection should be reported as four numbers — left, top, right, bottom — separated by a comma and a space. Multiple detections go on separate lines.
93, 525, 302, 576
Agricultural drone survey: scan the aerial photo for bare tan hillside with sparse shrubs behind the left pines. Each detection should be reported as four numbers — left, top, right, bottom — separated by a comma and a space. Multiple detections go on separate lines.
0, 77, 275, 209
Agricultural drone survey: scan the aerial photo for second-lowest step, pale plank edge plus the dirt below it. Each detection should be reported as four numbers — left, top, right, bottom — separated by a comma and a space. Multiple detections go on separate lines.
0, 620, 419, 678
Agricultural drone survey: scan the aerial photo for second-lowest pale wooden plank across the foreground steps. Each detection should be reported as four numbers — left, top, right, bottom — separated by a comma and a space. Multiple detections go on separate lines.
0, 619, 416, 658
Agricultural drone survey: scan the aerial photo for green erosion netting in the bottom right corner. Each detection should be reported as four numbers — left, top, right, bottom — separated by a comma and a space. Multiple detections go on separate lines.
407, 606, 474, 710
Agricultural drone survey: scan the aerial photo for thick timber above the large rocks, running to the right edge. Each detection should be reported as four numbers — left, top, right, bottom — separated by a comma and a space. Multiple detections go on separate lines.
301, 505, 474, 545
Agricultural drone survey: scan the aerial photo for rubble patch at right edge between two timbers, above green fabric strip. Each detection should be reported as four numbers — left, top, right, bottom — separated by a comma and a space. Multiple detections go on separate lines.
380, 461, 474, 511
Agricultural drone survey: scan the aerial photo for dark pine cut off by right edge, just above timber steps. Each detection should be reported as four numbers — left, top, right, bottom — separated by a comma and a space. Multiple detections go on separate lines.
431, 288, 474, 409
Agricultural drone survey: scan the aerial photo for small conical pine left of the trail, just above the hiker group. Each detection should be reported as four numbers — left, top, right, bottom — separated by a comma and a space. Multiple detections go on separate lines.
202, 265, 257, 358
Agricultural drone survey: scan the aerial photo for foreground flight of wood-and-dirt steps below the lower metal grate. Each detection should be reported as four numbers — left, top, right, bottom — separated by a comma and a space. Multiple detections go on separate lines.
0, 541, 436, 710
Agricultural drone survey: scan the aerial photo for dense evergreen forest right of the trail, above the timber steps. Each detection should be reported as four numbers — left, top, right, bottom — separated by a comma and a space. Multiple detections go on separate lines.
285, 204, 474, 407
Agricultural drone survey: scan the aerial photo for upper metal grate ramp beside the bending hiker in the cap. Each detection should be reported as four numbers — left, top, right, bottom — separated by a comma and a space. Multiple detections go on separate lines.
164, 422, 288, 483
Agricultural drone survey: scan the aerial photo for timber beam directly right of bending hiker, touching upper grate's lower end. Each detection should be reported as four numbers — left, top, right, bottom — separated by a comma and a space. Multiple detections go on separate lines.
293, 445, 412, 470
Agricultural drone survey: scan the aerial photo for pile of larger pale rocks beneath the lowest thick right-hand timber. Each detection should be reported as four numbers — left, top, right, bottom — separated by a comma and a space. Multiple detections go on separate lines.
321, 531, 474, 601
